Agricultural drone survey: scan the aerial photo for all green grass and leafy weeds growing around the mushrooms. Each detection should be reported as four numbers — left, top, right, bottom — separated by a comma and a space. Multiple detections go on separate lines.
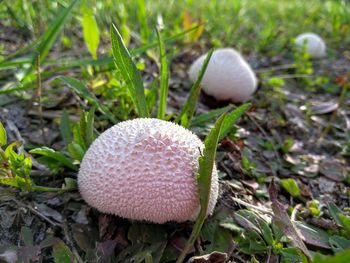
0, 0, 350, 262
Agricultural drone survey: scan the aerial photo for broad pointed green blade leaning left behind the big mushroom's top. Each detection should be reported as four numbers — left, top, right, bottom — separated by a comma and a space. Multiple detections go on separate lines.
111, 24, 149, 117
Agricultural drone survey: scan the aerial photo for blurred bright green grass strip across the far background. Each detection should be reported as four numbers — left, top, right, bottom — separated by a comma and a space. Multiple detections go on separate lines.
0, 0, 350, 57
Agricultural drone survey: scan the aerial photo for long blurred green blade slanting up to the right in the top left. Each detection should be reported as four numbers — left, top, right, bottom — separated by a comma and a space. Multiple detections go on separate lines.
27, 0, 79, 76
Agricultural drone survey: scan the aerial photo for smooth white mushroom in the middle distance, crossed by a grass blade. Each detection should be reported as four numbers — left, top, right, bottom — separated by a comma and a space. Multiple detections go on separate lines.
189, 48, 257, 102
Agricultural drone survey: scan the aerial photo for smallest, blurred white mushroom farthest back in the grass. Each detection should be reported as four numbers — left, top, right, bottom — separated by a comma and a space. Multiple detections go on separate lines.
295, 33, 326, 58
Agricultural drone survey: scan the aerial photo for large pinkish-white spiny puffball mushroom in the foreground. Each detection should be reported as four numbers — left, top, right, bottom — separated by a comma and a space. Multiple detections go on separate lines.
78, 118, 218, 223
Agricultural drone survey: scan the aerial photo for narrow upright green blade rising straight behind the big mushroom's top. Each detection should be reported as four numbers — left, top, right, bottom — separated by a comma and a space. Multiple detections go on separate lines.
156, 29, 169, 119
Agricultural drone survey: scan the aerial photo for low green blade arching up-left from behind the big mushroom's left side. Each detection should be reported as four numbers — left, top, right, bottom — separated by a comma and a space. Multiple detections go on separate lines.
58, 76, 115, 122
